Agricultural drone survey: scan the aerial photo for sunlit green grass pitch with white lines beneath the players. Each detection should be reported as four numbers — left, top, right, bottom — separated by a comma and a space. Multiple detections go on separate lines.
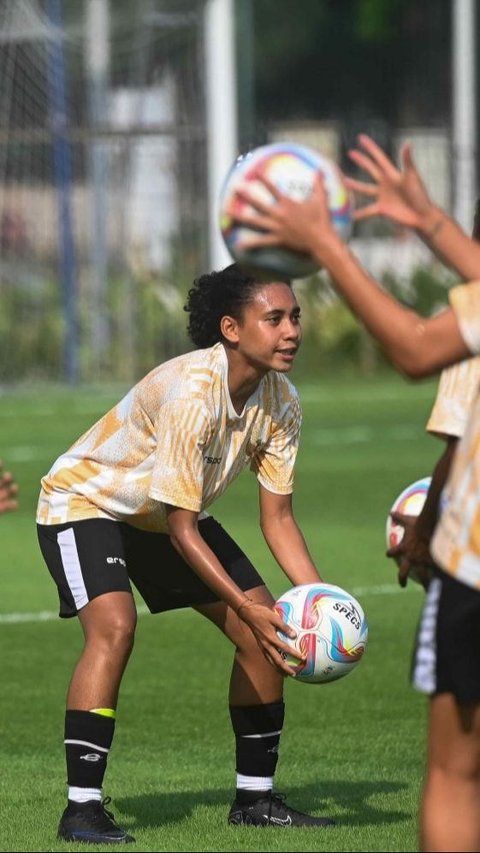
0, 375, 441, 851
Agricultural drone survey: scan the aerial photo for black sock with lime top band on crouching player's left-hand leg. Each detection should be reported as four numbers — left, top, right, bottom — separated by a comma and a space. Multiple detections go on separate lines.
65, 711, 115, 788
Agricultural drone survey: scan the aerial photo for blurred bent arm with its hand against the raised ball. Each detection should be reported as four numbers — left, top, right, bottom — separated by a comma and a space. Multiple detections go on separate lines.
232, 175, 472, 378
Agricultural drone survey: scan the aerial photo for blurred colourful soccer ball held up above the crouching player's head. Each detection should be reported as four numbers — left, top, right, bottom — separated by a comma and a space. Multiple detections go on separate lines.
220, 142, 353, 279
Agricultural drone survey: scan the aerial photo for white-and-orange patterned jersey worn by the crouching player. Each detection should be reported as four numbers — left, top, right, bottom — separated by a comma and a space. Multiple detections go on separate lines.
37, 344, 301, 532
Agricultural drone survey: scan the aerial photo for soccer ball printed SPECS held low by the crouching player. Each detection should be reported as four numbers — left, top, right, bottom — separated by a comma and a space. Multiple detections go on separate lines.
275, 581, 368, 684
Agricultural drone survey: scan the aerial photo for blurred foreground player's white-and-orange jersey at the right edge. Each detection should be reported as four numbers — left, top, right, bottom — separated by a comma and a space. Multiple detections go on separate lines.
431, 282, 480, 589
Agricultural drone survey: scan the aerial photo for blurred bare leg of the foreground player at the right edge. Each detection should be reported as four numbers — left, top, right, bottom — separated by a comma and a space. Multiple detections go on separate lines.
420, 693, 480, 853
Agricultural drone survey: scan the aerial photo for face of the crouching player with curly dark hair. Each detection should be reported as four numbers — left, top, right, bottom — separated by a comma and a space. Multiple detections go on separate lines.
237, 282, 302, 373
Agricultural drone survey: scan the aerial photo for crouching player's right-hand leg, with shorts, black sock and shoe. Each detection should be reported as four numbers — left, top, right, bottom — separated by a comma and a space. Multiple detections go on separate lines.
125, 518, 333, 826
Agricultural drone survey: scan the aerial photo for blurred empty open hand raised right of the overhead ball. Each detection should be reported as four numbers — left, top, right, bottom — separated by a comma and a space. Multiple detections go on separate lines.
345, 134, 438, 230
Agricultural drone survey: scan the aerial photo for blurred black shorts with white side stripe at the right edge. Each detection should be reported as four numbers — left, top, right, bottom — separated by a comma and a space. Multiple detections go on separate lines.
411, 571, 480, 704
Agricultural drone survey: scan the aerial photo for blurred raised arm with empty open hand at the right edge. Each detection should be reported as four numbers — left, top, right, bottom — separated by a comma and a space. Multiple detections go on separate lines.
345, 134, 480, 280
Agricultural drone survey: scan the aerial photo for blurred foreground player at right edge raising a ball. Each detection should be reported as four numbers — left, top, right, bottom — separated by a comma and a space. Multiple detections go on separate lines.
231, 136, 480, 853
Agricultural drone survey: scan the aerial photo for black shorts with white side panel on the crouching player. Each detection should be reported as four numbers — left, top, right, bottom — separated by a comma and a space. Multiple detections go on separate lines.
37, 517, 263, 617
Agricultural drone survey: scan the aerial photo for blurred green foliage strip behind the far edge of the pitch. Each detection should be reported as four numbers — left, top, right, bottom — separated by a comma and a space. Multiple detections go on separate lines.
0, 256, 453, 383
